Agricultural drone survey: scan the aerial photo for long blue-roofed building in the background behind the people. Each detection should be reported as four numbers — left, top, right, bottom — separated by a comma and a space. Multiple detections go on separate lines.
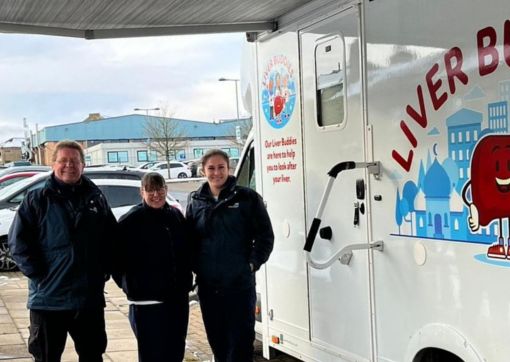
32, 114, 251, 165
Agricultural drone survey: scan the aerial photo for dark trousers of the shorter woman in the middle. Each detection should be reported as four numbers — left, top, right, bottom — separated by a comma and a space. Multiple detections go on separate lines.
129, 293, 189, 362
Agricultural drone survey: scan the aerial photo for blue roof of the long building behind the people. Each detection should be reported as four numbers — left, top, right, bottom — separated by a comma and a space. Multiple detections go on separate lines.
33, 114, 251, 145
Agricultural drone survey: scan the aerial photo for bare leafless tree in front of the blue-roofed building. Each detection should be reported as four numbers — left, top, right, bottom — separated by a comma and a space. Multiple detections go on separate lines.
145, 108, 187, 178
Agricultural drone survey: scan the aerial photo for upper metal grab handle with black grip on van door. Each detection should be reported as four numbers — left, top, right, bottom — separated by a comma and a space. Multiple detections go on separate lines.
303, 161, 381, 252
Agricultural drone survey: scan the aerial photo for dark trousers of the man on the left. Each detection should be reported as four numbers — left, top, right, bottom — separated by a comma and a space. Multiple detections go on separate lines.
28, 308, 107, 362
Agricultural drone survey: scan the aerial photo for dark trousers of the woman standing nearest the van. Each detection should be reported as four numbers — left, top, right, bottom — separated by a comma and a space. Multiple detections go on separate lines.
198, 286, 256, 362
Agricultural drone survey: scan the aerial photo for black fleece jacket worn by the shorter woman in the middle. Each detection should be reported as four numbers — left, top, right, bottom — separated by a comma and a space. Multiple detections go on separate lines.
113, 203, 192, 301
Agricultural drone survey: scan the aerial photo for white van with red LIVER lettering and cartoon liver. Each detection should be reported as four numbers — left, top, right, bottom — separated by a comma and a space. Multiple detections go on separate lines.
237, 0, 510, 362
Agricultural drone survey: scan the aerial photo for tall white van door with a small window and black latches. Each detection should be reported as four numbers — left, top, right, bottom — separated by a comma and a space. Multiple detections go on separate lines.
299, 5, 372, 360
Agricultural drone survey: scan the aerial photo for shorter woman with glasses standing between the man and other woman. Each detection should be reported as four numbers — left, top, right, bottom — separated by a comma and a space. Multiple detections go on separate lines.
114, 172, 192, 362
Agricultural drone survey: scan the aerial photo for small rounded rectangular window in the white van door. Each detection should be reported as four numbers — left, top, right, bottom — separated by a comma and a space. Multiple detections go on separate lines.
315, 35, 346, 127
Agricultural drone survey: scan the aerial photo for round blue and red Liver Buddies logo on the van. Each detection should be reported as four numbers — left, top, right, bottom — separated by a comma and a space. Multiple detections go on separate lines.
261, 55, 296, 128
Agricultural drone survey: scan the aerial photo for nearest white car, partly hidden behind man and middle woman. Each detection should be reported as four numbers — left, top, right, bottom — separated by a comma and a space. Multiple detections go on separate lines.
0, 179, 184, 272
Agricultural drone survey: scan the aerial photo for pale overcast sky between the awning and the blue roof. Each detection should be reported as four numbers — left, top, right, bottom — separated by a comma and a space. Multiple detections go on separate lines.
0, 34, 247, 143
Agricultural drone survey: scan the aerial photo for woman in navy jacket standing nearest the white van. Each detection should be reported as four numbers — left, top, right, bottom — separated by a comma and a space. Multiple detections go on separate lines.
186, 150, 274, 362
